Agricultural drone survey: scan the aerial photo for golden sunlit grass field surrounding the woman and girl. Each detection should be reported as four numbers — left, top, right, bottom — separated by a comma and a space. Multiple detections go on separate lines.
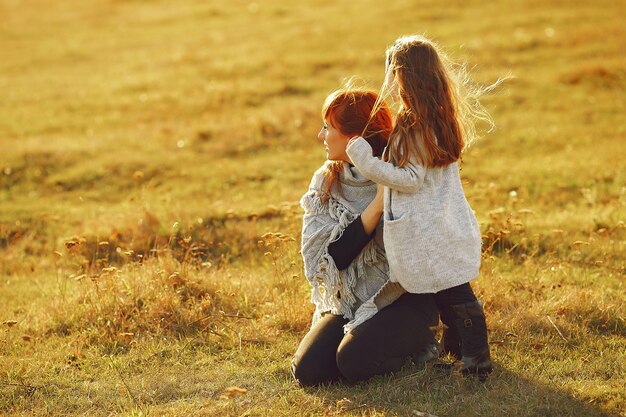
0, 0, 626, 417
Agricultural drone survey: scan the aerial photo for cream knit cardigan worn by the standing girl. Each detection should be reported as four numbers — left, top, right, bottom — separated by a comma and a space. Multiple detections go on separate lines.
347, 138, 481, 293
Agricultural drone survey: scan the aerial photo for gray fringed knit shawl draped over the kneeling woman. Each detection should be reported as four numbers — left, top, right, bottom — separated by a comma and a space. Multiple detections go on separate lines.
300, 162, 404, 332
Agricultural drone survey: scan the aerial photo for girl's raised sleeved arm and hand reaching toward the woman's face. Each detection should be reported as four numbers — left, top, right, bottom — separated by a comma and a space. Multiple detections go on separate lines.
346, 137, 426, 193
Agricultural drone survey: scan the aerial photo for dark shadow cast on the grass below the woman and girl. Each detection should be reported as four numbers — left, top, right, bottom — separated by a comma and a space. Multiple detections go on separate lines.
305, 365, 617, 417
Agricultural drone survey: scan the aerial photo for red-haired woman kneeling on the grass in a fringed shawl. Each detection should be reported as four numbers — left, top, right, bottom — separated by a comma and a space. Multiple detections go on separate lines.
292, 89, 437, 385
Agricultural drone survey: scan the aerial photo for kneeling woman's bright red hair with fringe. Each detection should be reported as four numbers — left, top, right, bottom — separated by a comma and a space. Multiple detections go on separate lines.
322, 87, 393, 204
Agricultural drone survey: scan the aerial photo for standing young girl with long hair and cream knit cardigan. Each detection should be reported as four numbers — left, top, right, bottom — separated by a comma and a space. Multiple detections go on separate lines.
347, 36, 492, 377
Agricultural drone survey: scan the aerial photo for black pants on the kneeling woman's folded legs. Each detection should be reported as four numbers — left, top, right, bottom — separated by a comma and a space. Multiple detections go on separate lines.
292, 293, 437, 385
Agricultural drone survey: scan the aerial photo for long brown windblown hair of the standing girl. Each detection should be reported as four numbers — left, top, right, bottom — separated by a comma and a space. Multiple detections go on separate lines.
370, 35, 499, 167
